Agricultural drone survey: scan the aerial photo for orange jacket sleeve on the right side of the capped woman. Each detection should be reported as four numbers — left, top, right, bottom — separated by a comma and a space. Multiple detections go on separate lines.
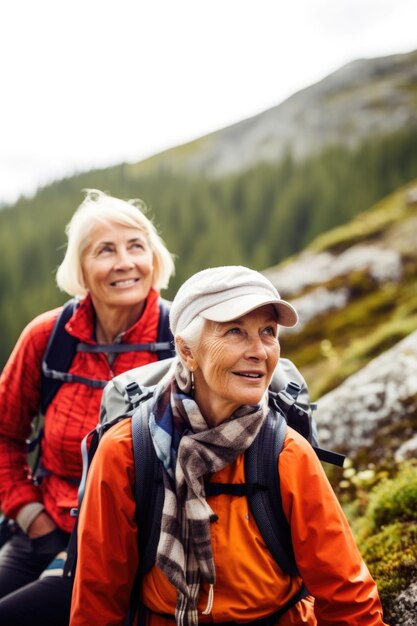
279, 428, 384, 626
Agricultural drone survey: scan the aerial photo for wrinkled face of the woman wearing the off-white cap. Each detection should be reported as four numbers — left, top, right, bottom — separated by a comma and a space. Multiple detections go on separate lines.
188, 305, 280, 425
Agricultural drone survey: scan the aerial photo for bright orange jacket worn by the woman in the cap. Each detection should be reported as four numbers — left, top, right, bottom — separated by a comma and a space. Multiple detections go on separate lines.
70, 420, 384, 626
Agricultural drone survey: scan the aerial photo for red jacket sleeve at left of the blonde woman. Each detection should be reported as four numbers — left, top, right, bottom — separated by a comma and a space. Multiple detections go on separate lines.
0, 309, 58, 518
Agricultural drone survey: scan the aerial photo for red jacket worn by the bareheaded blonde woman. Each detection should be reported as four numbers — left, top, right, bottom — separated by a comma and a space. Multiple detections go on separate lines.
0, 290, 159, 532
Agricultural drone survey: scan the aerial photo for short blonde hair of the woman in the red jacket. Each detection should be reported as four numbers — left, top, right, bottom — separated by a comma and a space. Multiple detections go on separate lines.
56, 189, 175, 297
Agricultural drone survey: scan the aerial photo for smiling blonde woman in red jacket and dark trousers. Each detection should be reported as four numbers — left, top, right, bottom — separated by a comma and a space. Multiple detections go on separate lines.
0, 191, 174, 626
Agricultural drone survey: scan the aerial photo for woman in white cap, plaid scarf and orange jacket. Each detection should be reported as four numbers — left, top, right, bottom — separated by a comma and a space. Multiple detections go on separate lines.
70, 266, 384, 626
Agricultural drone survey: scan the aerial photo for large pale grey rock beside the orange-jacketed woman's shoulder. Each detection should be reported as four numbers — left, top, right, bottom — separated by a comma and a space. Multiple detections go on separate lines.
316, 332, 417, 463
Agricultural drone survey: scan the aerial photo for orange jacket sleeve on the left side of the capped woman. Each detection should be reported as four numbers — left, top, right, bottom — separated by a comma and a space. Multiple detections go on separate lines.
70, 419, 139, 626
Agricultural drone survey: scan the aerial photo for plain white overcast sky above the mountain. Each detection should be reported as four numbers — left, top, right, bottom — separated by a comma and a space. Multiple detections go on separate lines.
0, 0, 417, 202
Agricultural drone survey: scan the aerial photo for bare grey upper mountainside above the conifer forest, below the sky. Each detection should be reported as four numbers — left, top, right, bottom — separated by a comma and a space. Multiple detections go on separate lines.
132, 51, 417, 176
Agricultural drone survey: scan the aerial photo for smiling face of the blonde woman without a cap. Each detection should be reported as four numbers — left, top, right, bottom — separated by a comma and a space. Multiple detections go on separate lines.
81, 222, 153, 308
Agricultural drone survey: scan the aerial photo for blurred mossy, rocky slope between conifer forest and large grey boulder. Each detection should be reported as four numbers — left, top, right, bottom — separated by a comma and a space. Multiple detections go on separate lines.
265, 178, 417, 398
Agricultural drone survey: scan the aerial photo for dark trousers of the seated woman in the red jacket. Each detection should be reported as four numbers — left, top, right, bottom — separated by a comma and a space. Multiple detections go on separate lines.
0, 529, 72, 626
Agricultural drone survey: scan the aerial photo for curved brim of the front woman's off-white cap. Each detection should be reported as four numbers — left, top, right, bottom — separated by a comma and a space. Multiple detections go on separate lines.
200, 294, 298, 328
